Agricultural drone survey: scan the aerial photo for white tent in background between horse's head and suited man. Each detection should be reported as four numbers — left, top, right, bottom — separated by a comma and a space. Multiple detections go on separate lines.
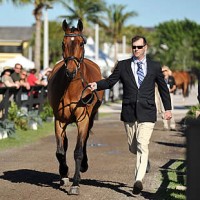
85, 37, 114, 76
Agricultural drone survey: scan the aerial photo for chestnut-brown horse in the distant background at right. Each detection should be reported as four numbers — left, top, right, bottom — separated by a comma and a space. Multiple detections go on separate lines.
172, 71, 191, 97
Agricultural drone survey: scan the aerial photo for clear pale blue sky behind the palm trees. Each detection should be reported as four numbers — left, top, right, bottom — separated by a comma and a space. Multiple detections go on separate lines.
0, 0, 200, 27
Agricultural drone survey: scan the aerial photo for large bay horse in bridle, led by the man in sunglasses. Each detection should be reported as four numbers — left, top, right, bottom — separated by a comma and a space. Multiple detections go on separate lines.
48, 19, 103, 195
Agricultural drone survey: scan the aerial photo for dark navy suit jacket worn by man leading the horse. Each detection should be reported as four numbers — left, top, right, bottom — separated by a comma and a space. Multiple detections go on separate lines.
97, 58, 171, 122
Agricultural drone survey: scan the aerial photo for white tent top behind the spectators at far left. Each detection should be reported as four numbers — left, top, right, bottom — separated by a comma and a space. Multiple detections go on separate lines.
0, 55, 35, 71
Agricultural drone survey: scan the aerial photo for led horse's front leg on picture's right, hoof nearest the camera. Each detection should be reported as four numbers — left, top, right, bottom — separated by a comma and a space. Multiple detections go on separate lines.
69, 116, 89, 195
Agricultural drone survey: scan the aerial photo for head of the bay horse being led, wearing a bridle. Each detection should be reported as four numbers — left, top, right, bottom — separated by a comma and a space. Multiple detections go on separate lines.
62, 20, 86, 79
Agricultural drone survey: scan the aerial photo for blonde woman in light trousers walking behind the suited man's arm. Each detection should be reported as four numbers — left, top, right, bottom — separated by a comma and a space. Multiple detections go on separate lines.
161, 65, 176, 131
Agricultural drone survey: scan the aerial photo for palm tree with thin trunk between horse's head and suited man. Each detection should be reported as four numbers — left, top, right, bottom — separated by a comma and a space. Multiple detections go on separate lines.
104, 4, 137, 61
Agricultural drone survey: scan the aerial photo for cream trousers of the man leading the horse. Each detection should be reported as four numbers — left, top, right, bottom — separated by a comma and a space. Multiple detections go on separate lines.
124, 122, 155, 181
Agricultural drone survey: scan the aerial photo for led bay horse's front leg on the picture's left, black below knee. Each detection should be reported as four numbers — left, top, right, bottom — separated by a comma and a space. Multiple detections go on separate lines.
55, 120, 69, 186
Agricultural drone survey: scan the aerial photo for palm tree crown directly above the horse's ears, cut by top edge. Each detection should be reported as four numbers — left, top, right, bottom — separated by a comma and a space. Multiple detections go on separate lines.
59, 0, 106, 33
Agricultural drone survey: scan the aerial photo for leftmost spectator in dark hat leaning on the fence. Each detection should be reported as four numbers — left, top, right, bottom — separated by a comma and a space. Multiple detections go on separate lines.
1, 67, 20, 89
